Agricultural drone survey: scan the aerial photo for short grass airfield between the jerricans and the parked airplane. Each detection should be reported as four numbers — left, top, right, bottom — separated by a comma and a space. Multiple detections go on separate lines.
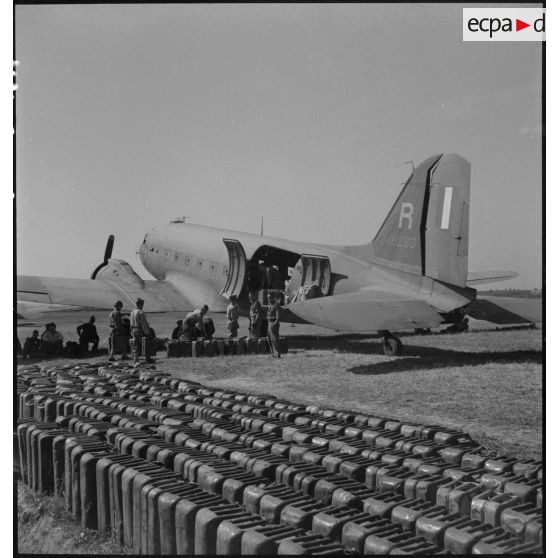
18, 311, 543, 458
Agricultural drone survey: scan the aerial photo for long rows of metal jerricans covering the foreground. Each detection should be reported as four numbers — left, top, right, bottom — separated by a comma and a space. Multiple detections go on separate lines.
14, 363, 543, 555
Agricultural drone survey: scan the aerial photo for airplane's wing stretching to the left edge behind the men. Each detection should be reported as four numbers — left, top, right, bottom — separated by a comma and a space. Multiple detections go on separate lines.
17, 275, 192, 312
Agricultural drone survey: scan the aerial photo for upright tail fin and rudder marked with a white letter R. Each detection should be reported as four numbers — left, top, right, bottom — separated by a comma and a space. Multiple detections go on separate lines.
372, 154, 471, 287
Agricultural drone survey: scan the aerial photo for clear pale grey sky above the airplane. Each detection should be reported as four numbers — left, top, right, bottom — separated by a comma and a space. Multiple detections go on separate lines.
15, 4, 543, 288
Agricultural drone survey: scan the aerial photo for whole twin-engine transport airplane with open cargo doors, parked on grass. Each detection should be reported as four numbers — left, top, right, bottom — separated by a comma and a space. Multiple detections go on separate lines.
17, 154, 541, 356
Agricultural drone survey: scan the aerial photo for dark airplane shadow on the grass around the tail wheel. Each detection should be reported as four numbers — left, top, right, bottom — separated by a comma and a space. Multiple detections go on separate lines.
289, 334, 543, 375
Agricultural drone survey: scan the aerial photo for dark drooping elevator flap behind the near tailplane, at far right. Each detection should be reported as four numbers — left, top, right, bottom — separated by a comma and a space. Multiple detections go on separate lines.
466, 296, 542, 324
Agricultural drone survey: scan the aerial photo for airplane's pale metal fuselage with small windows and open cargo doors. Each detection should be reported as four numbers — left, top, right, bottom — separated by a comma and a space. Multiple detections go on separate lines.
138, 222, 474, 322
